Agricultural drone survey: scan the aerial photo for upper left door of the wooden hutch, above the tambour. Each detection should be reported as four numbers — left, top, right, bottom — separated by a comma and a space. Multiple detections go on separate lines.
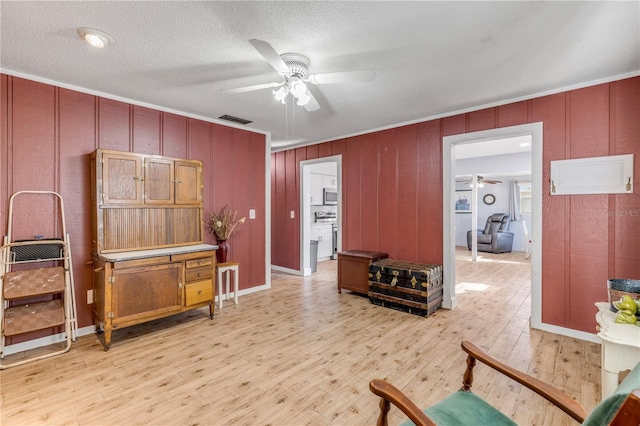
98, 152, 143, 204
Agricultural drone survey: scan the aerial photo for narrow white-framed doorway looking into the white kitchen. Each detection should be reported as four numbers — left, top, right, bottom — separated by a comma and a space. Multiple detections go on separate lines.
299, 155, 342, 276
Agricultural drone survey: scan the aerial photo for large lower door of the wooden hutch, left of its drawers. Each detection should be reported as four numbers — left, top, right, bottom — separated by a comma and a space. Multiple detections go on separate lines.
107, 263, 182, 328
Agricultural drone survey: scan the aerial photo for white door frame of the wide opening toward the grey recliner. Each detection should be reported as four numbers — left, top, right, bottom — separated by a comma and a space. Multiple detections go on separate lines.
443, 123, 542, 328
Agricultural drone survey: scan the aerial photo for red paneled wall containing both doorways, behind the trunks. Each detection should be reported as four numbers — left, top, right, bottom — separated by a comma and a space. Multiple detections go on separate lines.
271, 77, 640, 333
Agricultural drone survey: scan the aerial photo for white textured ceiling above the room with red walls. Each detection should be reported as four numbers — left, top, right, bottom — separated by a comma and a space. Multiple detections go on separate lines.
0, 0, 640, 150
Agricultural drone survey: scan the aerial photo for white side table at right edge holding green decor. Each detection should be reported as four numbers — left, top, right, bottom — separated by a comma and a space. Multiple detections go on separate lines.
596, 302, 640, 399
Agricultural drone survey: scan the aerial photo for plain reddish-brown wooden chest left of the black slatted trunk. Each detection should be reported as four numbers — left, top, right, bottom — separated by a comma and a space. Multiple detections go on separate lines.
338, 250, 388, 294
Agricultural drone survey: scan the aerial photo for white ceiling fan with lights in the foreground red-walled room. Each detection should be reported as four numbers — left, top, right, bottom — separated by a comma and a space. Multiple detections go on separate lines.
223, 39, 375, 111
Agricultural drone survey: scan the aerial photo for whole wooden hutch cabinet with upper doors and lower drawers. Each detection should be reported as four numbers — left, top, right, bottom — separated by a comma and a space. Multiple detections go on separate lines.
91, 149, 217, 350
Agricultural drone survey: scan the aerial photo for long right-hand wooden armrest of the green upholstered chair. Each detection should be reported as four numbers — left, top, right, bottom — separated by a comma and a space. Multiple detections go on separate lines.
461, 340, 587, 423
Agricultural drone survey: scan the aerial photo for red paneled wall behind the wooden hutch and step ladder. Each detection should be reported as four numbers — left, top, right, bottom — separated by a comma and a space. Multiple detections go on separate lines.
0, 74, 266, 342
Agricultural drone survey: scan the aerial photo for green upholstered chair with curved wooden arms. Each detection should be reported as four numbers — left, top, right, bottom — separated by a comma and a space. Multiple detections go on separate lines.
369, 341, 640, 426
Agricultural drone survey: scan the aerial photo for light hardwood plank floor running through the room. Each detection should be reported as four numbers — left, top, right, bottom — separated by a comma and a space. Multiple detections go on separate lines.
0, 249, 600, 426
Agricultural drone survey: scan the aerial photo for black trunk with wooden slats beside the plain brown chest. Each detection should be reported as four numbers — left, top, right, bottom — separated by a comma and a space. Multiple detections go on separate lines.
369, 259, 443, 317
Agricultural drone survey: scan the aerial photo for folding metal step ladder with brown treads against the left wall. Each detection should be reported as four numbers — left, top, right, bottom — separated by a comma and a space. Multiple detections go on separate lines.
0, 191, 78, 369
